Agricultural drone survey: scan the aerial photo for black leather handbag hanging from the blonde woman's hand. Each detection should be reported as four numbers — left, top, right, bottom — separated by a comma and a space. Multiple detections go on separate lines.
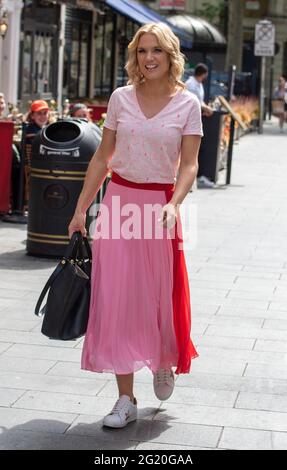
35, 232, 92, 340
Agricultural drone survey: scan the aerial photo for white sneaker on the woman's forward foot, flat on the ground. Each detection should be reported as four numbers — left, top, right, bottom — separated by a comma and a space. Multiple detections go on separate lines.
103, 395, 137, 428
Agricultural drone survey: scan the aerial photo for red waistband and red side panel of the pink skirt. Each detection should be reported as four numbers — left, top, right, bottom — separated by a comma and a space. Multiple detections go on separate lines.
112, 172, 198, 374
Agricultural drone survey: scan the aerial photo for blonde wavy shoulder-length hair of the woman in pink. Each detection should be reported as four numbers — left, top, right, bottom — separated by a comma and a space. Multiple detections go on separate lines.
125, 23, 186, 88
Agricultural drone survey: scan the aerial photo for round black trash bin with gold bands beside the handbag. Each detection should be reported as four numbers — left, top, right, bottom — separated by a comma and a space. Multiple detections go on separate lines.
27, 119, 103, 257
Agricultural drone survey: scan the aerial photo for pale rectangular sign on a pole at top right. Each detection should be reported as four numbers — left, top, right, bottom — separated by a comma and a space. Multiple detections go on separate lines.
254, 20, 275, 56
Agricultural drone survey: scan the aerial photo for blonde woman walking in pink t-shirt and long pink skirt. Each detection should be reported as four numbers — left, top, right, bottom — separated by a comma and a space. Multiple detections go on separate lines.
69, 23, 202, 428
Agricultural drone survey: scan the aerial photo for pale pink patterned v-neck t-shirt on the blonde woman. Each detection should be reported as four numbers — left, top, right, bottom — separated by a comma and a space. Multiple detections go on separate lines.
104, 85, 203, 183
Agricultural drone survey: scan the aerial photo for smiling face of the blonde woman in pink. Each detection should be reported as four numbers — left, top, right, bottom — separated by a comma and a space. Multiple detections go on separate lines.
137, 33, 170, 80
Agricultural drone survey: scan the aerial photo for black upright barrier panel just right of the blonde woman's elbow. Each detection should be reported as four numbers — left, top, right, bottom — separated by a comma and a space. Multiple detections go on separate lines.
197, 111, 228, 183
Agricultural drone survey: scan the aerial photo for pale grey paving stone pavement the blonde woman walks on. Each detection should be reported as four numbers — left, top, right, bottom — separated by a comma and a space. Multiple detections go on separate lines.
0, 121, 287, 450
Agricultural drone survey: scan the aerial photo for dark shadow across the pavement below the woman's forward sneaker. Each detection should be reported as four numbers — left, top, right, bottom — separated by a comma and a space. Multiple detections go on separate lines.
0, 409, 170, 450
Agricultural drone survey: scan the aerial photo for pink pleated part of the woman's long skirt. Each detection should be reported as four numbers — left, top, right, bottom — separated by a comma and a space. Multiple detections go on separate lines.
82, 181, 182, 374
